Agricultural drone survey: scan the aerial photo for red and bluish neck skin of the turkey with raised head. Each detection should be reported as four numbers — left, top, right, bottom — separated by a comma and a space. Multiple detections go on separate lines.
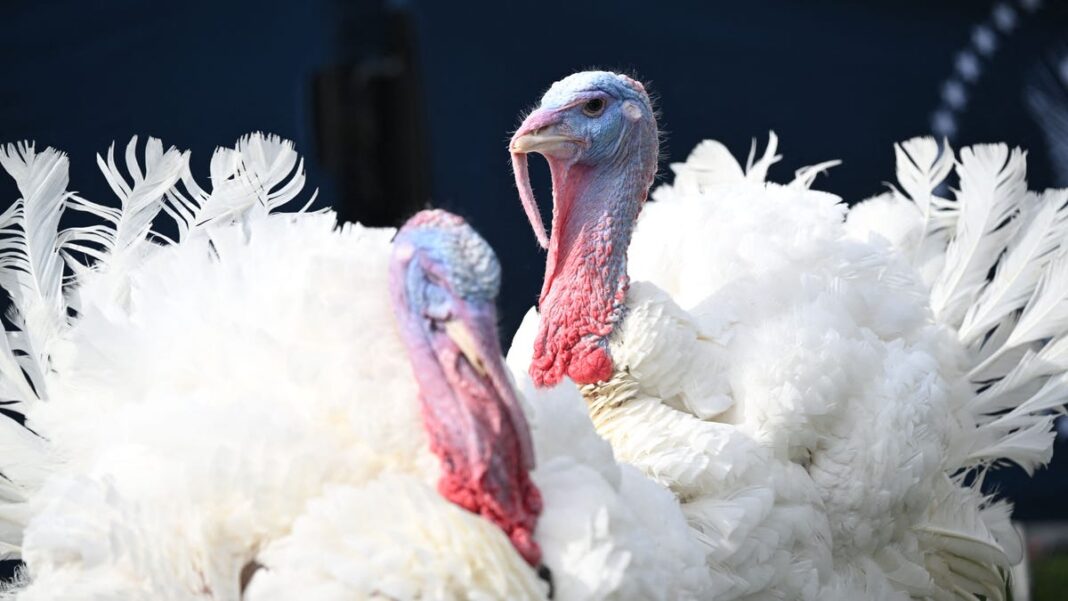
530, 157, 655, 386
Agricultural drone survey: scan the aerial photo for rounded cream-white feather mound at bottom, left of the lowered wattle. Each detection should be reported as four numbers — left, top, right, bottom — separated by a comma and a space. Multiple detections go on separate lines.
241, 475, 542, 601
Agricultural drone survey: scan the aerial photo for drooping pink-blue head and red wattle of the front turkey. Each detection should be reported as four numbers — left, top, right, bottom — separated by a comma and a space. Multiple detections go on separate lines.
390, 210, 541, 566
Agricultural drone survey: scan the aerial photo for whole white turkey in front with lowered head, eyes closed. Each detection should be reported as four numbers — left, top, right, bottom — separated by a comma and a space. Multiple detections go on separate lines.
0, 135, 709, 601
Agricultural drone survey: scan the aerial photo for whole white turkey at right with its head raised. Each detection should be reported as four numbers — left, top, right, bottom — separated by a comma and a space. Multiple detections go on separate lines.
509, 72, 1068, 601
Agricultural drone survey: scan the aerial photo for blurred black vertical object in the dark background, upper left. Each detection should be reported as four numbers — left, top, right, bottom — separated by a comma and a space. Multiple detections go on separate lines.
314, 1, 430, 226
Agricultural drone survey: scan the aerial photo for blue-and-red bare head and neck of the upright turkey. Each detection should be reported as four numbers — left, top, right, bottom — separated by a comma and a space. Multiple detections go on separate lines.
509, 72, 658, 386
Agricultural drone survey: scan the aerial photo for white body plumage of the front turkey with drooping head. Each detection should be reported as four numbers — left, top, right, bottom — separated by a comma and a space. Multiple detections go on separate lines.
0, 136, 709, 601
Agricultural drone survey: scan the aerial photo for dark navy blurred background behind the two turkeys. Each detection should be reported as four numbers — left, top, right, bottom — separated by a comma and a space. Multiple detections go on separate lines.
0, 0, 1068, 589
